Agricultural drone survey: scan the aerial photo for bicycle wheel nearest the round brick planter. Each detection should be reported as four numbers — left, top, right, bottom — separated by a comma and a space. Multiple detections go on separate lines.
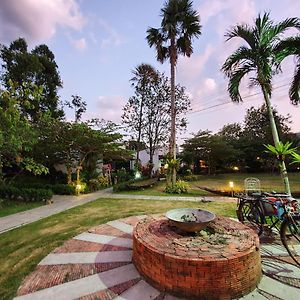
237, 201, 264, 235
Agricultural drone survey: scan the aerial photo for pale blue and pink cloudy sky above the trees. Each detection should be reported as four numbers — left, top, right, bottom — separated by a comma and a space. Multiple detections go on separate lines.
0, 0, 300, 143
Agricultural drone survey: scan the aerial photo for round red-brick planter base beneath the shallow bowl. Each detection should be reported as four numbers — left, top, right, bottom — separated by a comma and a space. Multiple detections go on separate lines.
133, 217, 262, 299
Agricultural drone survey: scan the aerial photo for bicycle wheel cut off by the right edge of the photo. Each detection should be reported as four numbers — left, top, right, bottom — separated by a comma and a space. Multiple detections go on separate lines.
280, 216, 300, 265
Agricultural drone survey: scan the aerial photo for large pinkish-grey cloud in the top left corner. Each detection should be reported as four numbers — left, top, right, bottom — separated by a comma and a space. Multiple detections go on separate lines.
0, 0, 85, 42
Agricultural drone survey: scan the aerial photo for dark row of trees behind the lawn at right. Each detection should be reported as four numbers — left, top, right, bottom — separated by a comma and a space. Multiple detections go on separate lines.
180, 105, 300, 174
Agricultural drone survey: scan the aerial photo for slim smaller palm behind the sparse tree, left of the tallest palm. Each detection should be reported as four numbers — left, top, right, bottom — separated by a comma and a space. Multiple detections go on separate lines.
130, 63, 158, 164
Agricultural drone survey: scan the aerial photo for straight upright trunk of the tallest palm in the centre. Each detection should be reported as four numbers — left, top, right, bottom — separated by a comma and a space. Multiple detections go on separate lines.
170, 38, 176, 187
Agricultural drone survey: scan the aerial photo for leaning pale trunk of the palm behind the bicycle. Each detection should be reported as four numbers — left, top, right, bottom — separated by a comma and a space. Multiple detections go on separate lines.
262, 87, 291, 195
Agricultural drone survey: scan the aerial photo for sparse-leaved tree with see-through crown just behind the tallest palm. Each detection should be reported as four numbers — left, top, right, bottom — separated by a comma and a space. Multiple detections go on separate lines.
122, 71, 190, 172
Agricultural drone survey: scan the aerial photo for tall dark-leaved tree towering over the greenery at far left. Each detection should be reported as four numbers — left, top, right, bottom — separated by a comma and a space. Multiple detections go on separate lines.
0, 38, 64, 122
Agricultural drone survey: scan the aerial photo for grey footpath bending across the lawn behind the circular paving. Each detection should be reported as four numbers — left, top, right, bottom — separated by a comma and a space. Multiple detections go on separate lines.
0, 188, 236, 234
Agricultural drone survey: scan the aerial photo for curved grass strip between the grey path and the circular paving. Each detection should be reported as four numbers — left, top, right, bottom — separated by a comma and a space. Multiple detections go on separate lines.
0, 199, 235, 300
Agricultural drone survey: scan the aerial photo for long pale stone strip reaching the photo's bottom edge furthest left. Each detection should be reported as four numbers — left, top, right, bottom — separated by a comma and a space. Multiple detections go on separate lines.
14, 264, 140, 300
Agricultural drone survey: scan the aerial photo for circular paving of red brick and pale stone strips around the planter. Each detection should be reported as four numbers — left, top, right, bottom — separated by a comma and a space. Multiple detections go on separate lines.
15, 216, 300, 300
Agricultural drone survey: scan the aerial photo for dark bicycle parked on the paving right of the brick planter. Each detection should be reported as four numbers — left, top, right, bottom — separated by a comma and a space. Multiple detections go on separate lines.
236, 193, 300, 265
